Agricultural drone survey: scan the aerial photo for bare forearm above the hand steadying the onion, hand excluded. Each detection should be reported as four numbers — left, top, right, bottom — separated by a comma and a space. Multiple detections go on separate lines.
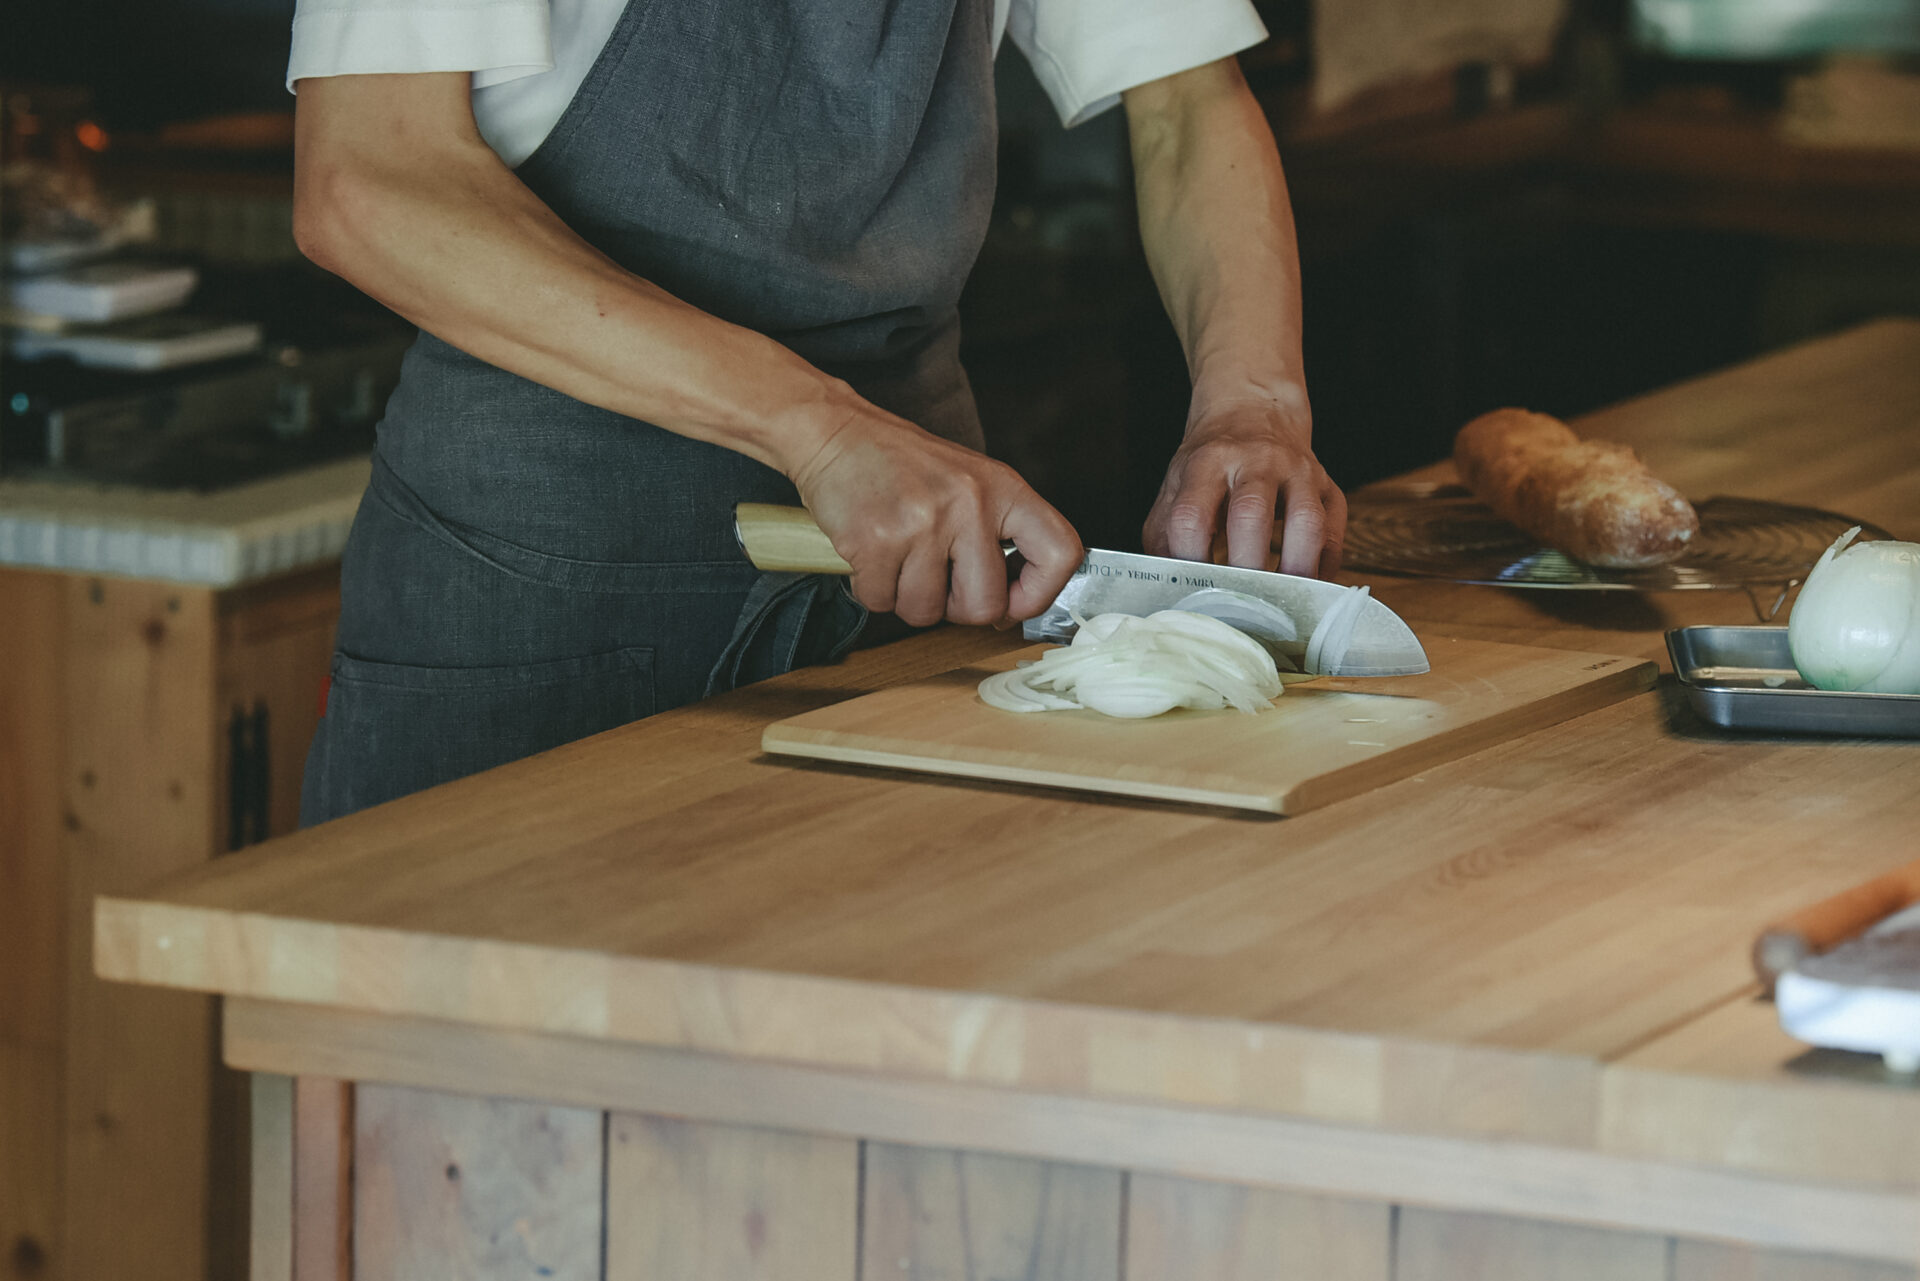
1125, 60, 1306, 415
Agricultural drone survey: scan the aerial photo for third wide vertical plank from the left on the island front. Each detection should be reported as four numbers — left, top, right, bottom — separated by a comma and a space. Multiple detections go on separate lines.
860, 1143, 1123, 1281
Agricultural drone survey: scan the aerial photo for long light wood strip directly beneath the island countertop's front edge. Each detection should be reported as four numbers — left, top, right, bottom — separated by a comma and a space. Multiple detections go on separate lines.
227, 1001, 1920, 1260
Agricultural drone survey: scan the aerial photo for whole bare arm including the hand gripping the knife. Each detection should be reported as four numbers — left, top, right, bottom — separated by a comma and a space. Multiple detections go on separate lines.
294, 75, 1081, 624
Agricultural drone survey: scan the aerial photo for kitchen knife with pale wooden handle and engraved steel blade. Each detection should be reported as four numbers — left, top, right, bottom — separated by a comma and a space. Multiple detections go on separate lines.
733, 503, 1428, 676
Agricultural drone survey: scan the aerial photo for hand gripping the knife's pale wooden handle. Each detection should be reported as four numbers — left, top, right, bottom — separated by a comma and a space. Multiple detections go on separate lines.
789, 401, 1085, 626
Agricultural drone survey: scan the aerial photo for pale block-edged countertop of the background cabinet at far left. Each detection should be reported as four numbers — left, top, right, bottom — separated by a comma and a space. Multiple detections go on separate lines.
0, 457, 369, 588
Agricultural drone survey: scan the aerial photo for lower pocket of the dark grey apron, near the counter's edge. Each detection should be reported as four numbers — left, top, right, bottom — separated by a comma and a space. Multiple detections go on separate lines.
301, 647, 655, 826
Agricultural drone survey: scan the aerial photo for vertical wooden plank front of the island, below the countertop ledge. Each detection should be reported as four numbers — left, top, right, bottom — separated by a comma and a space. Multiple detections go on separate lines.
334, 1085, 1920, 1281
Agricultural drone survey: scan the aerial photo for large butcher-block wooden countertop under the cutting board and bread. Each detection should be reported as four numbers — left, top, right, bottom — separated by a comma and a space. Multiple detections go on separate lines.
96, 321, 1920, 1189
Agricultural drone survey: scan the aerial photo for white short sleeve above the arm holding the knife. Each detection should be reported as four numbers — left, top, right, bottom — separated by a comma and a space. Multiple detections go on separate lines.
286, 0, 553, 88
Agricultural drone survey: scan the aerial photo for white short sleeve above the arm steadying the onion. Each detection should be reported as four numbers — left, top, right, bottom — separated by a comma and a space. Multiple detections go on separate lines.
1006, 0, 1267, 127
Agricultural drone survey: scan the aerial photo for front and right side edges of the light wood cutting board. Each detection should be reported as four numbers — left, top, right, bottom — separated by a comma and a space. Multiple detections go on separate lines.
760, 638, 1659, 814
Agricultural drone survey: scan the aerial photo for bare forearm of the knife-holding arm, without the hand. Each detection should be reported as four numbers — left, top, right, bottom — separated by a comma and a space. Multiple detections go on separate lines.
296, 81, 854, 474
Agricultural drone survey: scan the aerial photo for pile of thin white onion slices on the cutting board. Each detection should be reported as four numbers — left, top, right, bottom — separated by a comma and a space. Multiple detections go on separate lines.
979, 609, 1281, 718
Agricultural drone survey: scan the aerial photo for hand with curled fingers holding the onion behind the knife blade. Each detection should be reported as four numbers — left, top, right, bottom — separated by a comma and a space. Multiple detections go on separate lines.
1142, 399, 1346, 578
